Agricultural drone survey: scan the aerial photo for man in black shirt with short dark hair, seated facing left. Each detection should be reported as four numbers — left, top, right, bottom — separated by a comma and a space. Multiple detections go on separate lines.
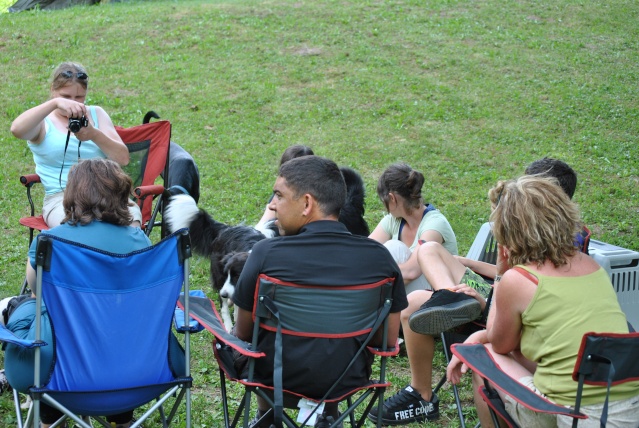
233, 156, 407, 426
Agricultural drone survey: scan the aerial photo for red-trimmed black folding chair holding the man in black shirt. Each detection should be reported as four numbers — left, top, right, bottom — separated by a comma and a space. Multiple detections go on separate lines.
178, 275, 399, 428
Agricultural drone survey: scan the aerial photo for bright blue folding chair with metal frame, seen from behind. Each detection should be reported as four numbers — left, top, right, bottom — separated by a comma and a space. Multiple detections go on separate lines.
0, 230, 192, 428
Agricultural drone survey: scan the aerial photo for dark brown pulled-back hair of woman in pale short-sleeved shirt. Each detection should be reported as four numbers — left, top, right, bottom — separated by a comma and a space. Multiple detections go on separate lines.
377, 163, 424, 210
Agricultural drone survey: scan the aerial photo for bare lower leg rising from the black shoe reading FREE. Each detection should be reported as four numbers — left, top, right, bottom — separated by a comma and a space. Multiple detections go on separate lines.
401, 290, 435, 401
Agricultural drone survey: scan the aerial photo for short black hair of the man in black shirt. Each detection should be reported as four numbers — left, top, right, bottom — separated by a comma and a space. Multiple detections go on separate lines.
279, 155, 346, 216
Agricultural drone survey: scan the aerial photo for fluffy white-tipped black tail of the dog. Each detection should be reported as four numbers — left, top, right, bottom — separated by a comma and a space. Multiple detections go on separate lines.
164, 195, 228, 256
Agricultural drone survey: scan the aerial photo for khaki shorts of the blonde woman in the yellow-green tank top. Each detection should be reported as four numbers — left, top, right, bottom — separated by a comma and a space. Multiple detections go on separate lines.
504, 376, 639, 428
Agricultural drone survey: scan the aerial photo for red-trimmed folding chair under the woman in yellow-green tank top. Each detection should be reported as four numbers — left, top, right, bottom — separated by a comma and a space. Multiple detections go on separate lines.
452, 333, 639, 428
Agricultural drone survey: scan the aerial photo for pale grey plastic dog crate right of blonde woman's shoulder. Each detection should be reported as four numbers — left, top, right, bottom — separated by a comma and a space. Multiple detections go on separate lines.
588, 239, 639, 331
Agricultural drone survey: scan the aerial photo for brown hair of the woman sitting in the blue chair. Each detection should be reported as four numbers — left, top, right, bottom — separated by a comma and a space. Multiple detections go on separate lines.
62, 158, 133, 226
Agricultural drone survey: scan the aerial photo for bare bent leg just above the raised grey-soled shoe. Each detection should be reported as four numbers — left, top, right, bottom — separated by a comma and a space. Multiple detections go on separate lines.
417, 242, 466, 290
